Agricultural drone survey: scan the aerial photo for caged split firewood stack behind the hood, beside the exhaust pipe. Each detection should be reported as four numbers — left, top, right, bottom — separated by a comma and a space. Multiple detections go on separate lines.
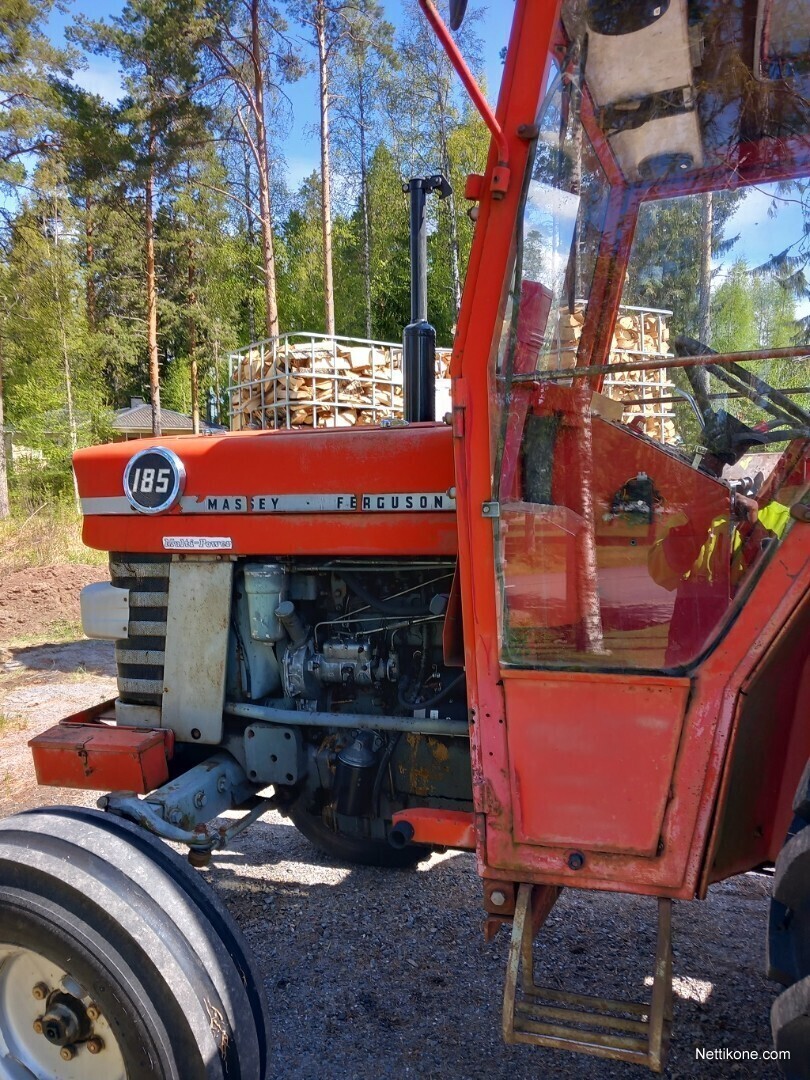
230, 338, 450, 431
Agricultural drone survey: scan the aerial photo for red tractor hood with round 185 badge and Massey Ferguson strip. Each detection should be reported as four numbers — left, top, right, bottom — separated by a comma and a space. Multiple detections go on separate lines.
73, 423, 456, 556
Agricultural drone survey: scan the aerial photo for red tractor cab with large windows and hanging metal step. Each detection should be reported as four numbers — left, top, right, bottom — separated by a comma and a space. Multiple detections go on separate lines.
454, 0, 810, 1067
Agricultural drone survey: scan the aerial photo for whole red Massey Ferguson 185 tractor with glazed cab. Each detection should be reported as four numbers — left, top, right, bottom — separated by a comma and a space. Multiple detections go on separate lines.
0, 0, 810, 1080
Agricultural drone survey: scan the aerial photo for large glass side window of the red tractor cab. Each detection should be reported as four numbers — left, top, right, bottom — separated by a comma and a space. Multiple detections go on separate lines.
495, 3, 810, 670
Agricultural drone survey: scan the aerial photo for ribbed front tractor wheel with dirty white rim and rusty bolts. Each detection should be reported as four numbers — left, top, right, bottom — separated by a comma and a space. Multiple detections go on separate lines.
0, 807, 273, 1080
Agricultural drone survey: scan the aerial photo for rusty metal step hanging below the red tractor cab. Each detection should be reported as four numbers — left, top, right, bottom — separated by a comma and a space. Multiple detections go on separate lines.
503, 885, 672, 1072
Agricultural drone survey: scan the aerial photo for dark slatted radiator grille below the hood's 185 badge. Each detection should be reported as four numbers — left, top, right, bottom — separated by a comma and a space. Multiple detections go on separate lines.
110, 552, 172, 705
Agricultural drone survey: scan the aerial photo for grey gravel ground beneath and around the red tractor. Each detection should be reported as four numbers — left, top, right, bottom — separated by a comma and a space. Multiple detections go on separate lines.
0, 642, 779, 1080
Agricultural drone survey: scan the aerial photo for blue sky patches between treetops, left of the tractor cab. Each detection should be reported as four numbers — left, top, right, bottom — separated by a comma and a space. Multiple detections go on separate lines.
50, 0, 513, 190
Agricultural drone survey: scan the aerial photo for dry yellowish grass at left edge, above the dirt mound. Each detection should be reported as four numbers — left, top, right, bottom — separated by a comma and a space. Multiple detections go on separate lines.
0, 503, 108, 572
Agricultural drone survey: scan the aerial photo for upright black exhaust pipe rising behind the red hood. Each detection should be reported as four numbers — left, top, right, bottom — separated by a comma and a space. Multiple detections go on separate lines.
402, 175, 453, 423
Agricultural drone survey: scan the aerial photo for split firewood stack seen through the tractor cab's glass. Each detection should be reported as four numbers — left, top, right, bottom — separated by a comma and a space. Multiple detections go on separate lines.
543, 308, 675, 443
